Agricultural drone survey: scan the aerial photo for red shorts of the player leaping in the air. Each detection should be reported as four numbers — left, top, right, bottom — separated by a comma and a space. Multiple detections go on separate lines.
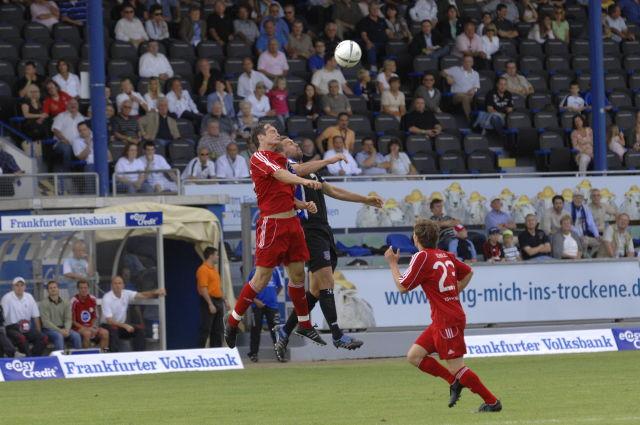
256, 216, 309, 268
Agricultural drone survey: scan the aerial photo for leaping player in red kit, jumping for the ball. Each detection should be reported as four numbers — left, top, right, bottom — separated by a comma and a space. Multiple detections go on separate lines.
224, 123, 326, 348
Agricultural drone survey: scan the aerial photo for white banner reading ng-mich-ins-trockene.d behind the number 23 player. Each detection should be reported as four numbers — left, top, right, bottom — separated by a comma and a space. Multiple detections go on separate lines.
312, 260, 640, 329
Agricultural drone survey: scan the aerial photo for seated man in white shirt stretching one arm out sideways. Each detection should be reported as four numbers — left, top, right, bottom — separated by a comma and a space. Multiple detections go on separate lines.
102, 276, 166, 353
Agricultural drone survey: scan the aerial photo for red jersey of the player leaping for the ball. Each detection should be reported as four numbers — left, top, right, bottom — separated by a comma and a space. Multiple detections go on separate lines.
249, 151, 295, 217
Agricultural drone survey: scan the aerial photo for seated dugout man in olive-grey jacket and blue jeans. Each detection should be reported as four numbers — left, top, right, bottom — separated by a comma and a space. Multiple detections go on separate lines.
38, 280, 82, 351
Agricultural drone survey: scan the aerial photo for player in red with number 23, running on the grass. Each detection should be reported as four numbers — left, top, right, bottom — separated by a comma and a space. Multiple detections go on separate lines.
384, 220, 502, 412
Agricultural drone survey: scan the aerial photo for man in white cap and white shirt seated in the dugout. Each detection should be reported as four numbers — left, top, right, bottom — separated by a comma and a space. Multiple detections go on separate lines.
0, 276, 47, 357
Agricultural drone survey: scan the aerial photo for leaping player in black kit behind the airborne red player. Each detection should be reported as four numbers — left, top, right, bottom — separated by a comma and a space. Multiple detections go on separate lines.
274, 138, 383, 361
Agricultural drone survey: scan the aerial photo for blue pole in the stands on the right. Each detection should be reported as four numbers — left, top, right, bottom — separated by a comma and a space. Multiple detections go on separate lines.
588, 0, 607, 171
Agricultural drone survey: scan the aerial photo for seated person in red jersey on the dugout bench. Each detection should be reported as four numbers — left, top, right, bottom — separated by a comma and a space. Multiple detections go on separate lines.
71, 279, 109, 351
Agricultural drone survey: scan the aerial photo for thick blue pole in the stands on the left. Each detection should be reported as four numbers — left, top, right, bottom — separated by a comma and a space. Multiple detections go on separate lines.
87, 0, 109, 196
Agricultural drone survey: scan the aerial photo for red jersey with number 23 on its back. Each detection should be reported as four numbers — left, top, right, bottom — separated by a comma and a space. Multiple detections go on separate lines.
400, 249, 471, 327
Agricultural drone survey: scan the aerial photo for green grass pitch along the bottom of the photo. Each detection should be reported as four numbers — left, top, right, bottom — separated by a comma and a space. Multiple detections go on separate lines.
0, 352, 640, 425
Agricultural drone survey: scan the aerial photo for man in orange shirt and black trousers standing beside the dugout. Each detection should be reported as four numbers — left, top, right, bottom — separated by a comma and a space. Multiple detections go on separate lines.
196, 247, 229, 348
